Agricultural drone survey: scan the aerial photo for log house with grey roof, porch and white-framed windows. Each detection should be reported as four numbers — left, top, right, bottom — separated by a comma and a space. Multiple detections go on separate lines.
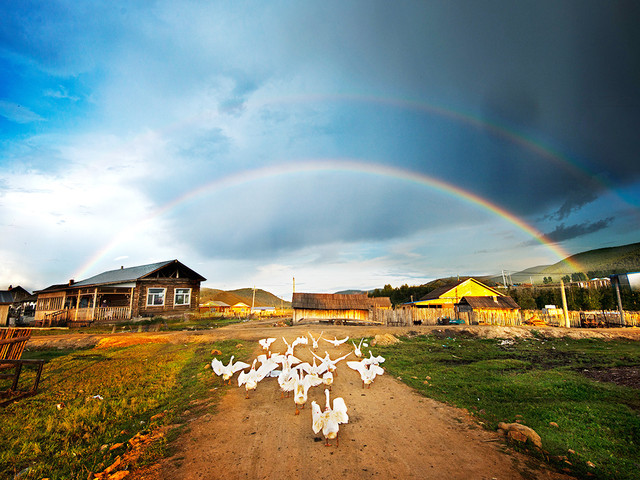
35, 260, 206, 325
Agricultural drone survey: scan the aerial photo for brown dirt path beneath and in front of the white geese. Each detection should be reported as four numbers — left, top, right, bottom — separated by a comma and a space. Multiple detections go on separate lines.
151, 326, 570, 480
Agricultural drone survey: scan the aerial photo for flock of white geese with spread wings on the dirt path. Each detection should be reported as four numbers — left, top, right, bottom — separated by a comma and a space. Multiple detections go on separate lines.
211, 332, 384, 446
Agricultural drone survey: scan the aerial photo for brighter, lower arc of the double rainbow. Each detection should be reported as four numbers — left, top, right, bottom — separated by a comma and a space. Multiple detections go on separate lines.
74, 159, 581, 278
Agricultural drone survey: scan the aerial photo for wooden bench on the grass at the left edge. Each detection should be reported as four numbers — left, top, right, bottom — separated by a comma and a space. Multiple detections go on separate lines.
0, 328, 44, 406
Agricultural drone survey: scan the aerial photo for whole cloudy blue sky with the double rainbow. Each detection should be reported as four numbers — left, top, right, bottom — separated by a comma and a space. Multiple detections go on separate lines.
0, 0, 640, 300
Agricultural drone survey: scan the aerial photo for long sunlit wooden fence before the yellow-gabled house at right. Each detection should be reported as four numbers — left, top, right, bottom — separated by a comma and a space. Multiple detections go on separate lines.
376, 307, 640, 328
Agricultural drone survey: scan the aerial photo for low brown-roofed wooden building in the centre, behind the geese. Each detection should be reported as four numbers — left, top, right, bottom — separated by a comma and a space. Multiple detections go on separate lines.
292, 293, 391, 323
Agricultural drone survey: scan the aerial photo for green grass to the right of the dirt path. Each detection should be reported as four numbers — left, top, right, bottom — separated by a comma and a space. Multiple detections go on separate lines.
374, 336, 640, 480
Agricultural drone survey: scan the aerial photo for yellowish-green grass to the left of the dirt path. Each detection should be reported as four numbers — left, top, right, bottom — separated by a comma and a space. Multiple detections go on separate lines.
0, 340, 250, 480
